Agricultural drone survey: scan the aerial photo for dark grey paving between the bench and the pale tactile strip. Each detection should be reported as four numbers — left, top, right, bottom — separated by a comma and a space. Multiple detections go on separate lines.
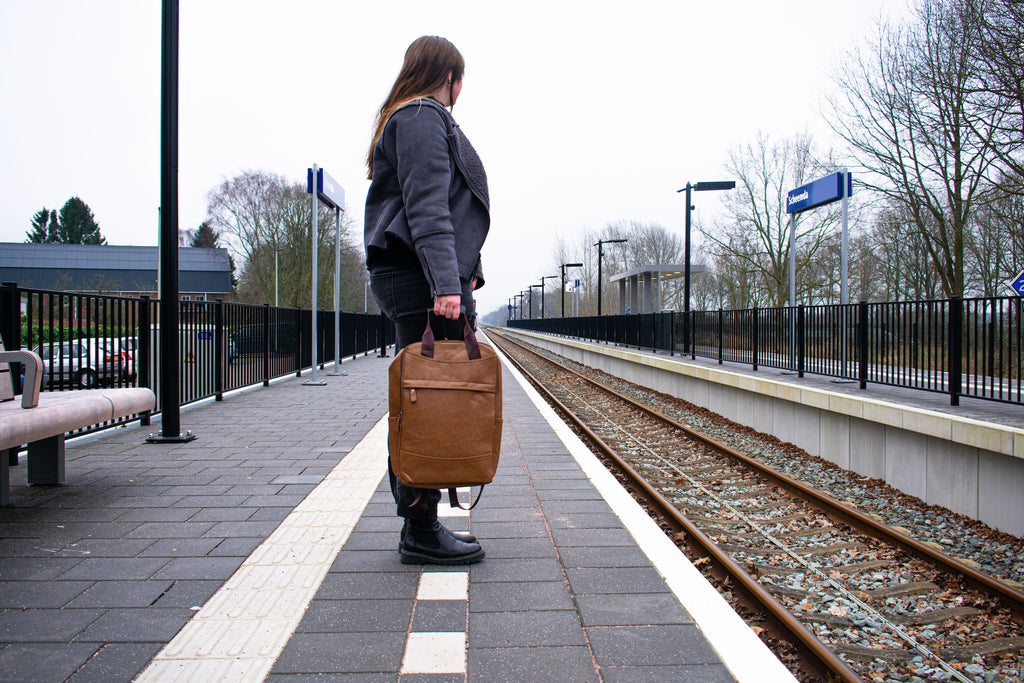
0, 357, 386, 683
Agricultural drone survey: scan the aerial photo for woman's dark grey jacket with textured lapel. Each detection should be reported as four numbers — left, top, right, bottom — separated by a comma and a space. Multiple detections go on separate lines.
362, 99, 490, 296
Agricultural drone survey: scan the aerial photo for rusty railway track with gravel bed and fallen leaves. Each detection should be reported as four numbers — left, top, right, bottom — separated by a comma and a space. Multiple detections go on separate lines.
486, 329, 1024, 683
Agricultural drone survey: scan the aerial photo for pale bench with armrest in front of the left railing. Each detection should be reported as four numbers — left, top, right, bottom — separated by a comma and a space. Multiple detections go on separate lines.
0, 341, 157, 505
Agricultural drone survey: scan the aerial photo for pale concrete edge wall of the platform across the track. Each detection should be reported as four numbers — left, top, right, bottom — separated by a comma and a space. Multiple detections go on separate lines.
507, 330, 1024, 536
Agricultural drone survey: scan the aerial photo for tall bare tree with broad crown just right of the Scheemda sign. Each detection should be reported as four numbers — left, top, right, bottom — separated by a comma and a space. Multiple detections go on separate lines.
829, 0, 1007, 296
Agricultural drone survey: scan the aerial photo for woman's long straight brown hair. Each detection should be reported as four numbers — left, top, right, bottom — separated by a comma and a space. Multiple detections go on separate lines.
367, 36, 466, 179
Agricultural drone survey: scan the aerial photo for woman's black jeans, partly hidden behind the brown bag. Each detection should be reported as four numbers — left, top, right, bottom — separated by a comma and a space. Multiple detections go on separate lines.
370, 269, 476, 521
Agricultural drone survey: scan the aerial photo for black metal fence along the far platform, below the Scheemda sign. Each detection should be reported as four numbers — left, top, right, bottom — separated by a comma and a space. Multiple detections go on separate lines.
509, 297, 1024, 405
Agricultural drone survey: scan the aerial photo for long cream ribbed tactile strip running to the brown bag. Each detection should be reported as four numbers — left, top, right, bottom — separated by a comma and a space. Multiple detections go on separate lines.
135, 417, 389, 683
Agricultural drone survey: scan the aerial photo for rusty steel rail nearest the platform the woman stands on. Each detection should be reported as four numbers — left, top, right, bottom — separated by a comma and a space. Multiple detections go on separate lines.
487, 327, 863, 683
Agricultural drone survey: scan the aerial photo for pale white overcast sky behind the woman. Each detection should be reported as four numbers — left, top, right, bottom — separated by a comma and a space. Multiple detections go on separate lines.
0, 0, 905, 312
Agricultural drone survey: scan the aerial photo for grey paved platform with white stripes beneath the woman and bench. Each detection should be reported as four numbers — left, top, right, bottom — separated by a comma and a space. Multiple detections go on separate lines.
0, 339, 793, 683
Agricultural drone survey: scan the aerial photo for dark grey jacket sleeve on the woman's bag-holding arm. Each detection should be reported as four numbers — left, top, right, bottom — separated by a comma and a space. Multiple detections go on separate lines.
392, 106, 462, 296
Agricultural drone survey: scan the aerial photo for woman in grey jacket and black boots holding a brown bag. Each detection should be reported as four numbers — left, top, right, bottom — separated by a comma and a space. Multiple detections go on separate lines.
364, 36, 490, 564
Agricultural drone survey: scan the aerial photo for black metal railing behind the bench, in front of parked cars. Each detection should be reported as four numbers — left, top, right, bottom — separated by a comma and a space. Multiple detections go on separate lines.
0, 283, 394, 433
